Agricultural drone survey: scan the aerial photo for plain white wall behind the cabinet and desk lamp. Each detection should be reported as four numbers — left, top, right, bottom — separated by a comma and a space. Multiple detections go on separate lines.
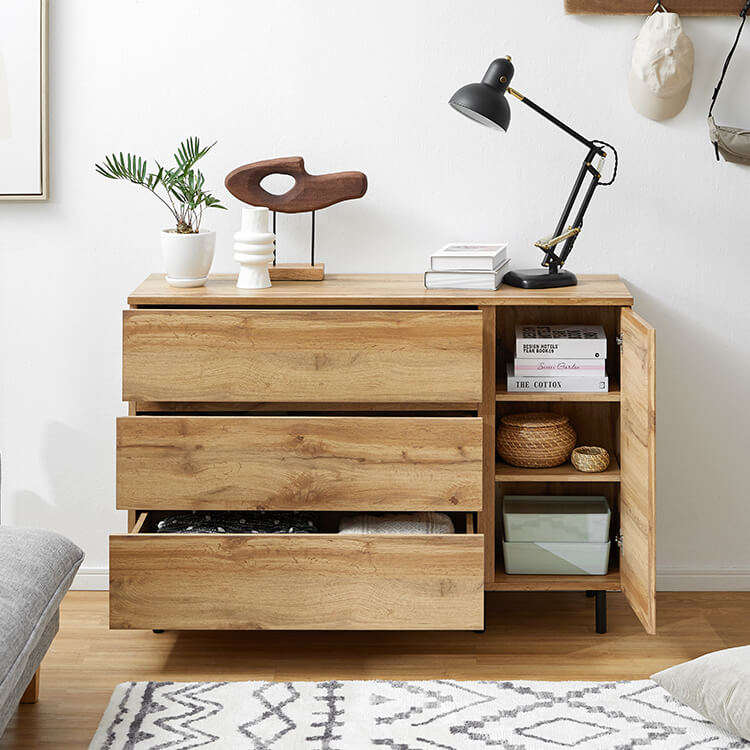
0, 0, 750, 588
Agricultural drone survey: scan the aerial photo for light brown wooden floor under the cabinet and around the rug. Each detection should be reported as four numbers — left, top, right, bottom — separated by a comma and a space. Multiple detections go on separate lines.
0, 591, 750, 750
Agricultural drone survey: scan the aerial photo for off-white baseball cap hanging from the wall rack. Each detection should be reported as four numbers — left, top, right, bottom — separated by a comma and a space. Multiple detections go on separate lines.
628, 3, 695, 120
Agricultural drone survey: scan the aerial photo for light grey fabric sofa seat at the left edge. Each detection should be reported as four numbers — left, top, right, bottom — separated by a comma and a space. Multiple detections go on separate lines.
0, 526, 83, 731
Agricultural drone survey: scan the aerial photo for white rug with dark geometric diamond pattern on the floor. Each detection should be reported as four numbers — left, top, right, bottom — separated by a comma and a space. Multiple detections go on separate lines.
89, 680, 750, 750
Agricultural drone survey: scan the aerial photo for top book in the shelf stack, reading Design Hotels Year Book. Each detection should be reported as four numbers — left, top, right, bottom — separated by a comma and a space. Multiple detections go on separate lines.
516, 325, 607, 359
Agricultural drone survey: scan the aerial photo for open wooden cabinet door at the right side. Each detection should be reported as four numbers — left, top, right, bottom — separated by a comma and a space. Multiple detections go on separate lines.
620, 307, 656, 634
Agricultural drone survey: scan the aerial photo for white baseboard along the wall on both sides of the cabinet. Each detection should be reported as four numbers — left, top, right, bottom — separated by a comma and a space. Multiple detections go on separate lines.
71, 566, 750, 591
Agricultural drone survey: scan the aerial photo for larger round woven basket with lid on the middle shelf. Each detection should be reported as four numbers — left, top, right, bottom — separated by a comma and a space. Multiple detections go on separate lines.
497, 413, 576, 469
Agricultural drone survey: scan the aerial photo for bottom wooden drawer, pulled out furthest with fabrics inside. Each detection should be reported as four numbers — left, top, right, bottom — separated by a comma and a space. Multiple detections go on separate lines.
110, 513, 484, 630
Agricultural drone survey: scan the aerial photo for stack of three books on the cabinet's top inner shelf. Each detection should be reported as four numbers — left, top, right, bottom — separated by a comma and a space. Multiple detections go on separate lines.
507, 325, 609, 393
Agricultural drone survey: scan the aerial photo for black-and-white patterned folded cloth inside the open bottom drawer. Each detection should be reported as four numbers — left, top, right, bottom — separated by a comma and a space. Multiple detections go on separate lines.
156, 510, 320, 534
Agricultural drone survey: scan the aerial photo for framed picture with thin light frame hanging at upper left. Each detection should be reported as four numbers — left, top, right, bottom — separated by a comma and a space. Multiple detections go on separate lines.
0, 0, 49, 201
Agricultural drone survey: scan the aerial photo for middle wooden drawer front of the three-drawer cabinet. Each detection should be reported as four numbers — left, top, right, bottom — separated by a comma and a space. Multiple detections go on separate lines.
117, 417, 482, 511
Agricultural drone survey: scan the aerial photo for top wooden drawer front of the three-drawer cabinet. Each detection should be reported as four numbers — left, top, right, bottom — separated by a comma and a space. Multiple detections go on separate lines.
122, 309, 482, 403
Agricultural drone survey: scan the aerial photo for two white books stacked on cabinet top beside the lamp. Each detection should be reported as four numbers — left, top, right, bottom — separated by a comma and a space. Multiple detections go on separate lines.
424, 244, 510, 290
